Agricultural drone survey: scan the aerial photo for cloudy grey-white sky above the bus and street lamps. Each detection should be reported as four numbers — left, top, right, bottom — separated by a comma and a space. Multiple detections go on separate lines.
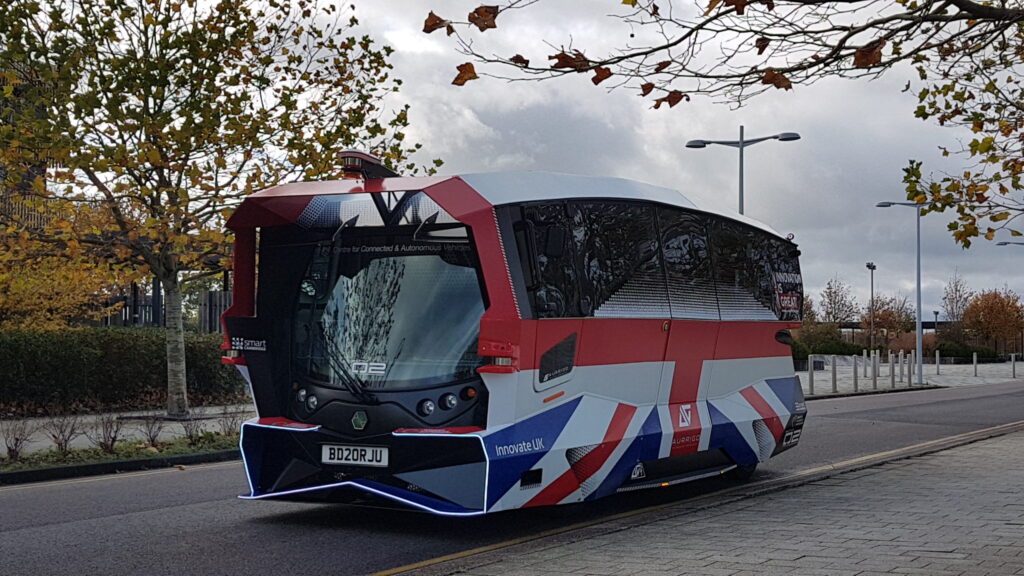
356, 0, 1024, 320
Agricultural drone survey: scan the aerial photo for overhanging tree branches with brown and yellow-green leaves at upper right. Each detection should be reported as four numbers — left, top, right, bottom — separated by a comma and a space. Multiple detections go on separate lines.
423, 0, 1024, 246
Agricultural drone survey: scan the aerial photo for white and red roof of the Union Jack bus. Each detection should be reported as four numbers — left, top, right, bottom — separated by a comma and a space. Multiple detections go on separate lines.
235, 172, 781, 237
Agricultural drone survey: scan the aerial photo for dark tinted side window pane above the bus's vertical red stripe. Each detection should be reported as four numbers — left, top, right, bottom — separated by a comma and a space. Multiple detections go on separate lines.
658, 208, 719, 320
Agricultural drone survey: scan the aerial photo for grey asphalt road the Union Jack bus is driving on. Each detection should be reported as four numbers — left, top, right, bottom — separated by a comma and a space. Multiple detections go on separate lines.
0, 383, 1024, 576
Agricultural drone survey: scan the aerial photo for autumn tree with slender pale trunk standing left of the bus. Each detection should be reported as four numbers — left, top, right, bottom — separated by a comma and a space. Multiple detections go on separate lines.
0, 0, 432, 415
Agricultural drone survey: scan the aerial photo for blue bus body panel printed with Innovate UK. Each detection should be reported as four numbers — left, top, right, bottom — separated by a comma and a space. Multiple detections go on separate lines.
483, 398, 582, 508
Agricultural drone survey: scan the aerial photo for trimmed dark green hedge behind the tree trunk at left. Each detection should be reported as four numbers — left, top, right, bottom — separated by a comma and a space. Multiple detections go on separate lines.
0, 328, 245, 412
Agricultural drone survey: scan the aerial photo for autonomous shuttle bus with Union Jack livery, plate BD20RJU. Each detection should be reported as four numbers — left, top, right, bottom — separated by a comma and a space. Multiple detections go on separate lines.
223, 153, 806, 516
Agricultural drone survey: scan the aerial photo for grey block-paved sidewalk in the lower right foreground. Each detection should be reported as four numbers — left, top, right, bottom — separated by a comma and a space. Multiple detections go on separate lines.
415, 431, 1024, 576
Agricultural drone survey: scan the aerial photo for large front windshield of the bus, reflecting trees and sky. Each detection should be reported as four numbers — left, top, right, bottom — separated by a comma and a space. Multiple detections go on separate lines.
293, 230, 484, 390
